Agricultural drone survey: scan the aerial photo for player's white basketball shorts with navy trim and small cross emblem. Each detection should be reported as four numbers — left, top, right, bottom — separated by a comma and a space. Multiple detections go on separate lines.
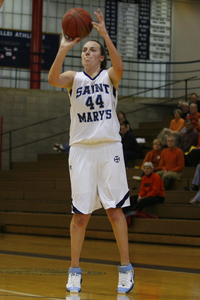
69, 142, 130, 214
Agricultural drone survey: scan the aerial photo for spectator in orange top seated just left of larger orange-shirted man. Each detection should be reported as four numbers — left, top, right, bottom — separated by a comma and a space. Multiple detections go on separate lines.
141, 139, 163, 172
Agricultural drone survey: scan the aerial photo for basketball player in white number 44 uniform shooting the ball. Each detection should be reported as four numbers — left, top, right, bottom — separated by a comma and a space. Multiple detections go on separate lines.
48, 9, 134, 293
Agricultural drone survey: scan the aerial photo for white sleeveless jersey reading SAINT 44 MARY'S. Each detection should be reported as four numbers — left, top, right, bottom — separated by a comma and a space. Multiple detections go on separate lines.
70, 70, 121, 146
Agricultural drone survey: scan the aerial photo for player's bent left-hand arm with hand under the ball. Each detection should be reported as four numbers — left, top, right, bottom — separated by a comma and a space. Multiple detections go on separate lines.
48, 34, 80, 90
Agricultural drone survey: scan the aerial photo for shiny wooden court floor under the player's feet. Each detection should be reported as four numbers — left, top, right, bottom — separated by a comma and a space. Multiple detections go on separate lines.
0, 233, 200, 300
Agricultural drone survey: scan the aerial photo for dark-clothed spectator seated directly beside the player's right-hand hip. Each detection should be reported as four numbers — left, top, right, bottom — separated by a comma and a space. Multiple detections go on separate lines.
120, 123, 142, 167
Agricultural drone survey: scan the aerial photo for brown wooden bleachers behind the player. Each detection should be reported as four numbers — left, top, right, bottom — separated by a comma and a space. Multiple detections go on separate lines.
0, 115, 200, 246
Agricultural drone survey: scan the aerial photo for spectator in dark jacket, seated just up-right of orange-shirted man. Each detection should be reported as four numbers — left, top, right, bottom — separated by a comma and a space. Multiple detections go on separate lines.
180, 119, 199, 153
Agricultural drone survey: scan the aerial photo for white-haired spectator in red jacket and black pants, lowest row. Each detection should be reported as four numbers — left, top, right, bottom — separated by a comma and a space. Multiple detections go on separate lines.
123, 162, 165, 216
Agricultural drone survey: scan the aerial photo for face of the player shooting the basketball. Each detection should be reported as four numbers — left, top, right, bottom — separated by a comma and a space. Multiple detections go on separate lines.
81, 41, 104, 67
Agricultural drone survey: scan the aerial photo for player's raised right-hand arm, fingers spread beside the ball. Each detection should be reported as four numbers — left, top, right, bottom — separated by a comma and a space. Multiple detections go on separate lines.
92, 9, 123, 89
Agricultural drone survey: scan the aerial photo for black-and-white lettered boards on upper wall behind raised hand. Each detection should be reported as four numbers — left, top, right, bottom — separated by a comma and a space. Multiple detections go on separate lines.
105, 0, 171, 61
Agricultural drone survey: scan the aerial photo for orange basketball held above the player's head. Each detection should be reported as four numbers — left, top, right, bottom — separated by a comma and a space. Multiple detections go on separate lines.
62, 8, 92, 39
